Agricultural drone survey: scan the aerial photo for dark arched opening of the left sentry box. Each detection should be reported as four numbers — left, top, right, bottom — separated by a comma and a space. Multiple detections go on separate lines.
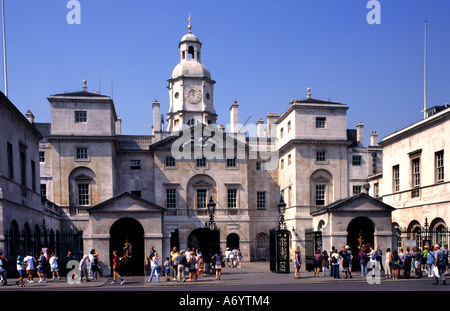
109, 218, 145, 275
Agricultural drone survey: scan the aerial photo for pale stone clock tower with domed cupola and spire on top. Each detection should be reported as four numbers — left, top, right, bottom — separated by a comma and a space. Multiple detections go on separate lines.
167, 17, 217, 132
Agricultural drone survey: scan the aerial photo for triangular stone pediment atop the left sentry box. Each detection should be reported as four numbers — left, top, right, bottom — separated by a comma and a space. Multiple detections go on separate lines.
88, 192, 165, 213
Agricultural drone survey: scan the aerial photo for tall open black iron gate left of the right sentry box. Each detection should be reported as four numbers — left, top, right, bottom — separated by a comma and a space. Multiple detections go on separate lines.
270, 229, 291, 273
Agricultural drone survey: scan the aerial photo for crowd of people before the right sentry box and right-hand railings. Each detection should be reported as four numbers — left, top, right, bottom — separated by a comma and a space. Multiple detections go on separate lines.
294, 244, 449, 285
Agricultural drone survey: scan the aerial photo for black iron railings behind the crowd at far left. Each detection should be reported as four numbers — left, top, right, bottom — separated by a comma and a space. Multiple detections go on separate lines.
3, 230, 83, 276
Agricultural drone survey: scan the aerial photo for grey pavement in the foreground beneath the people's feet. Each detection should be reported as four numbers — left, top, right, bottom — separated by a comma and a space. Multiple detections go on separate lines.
0, 262, 442, 291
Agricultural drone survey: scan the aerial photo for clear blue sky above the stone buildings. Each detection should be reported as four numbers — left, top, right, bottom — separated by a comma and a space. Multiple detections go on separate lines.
0, 0, 450, 143
